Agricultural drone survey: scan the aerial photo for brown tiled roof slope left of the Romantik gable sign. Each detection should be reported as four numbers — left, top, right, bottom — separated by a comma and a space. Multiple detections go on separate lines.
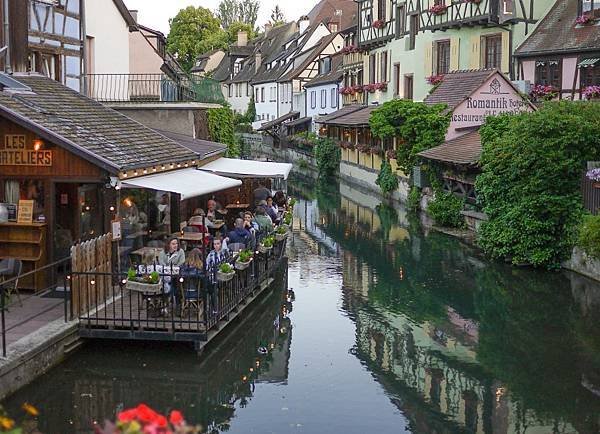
424, 69, 497, 111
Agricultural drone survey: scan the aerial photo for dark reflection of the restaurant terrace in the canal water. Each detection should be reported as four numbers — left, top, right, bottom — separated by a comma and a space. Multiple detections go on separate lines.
8, 280, 294, 433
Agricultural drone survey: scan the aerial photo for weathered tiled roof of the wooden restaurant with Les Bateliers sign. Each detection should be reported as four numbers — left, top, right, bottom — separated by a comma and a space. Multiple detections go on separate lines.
0, 74, 198, 172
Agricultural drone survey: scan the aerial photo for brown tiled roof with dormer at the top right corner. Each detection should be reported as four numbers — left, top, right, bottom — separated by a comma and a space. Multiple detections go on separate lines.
515, 0, 600, 56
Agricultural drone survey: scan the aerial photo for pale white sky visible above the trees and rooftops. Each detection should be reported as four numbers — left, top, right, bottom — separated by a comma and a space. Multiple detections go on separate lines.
124, 0, 317, 35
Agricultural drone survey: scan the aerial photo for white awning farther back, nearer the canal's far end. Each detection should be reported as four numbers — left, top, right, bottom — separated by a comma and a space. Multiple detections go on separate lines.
199, 158, 292, 179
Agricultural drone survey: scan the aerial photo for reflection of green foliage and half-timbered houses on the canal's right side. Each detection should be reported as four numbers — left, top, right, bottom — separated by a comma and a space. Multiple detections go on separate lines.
288, 176, 600, 433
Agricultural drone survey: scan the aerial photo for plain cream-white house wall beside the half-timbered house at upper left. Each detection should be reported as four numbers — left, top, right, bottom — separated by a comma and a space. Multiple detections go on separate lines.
85, 0, 129, 74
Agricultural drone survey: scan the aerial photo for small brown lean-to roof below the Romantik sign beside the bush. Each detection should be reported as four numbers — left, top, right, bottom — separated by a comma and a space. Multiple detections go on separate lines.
418, 131, 481, 165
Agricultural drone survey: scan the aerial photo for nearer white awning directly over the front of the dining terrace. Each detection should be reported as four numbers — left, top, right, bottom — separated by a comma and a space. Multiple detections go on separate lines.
123, 168, 242, 200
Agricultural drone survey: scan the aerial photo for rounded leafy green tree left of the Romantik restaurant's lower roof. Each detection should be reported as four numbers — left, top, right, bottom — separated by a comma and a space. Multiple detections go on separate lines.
369, 99, 450, 173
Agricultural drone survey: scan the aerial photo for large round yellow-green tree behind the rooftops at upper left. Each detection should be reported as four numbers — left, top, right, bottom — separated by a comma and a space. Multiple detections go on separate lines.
167, 6, 226, 71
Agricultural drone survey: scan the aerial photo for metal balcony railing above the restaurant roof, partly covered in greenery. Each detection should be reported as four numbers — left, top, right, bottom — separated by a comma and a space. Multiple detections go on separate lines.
85, 74, 224, 104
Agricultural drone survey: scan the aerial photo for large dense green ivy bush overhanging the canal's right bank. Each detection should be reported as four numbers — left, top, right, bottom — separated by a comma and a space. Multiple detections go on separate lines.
476, 102, 600, 267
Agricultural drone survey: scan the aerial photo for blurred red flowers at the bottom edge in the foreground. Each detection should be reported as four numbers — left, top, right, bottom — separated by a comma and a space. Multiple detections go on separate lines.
96, 404, 200, 434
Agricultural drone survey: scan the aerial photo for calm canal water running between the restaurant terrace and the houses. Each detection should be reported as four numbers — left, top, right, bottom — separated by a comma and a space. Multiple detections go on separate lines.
4, 179, 600, 434
